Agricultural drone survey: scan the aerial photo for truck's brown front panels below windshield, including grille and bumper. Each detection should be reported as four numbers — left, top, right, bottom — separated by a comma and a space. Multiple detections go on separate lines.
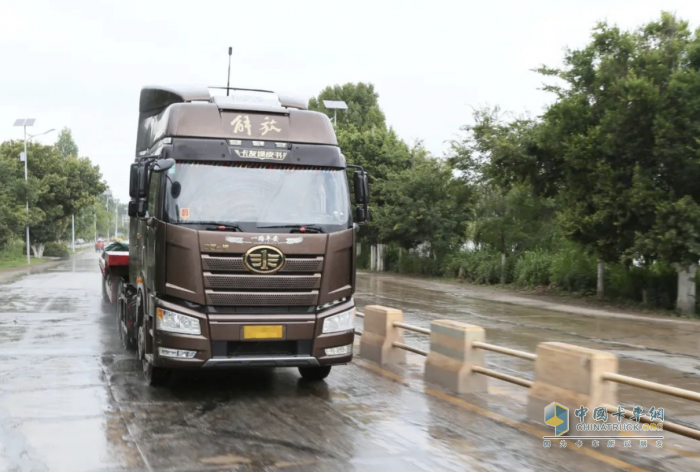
155, 224, 355, 368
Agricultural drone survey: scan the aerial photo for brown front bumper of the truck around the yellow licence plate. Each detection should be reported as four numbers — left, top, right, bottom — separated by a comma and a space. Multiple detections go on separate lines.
153, 300, 355, 369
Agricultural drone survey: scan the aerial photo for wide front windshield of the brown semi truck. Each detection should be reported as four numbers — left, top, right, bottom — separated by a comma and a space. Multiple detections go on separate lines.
165, 162, 350, 232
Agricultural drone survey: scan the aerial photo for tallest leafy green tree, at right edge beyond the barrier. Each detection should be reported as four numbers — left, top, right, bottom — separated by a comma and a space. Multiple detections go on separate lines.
478, 13, 700, 311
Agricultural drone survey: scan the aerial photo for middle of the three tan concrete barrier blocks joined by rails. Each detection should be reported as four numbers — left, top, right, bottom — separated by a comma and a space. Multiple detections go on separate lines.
425, 320, 488, 393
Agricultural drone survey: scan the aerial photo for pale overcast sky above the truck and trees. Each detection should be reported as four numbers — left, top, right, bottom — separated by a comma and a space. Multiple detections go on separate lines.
0, 0, 700, 201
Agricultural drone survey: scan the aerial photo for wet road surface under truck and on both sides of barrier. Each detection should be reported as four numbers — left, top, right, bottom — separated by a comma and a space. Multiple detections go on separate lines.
0, 253, 700, 472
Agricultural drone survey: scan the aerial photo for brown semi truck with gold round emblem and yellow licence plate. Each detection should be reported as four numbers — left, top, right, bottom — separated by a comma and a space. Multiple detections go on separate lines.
113, 87, 368, 384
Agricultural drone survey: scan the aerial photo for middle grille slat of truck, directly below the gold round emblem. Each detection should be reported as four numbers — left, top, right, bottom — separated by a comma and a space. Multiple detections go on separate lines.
204, 273, 321, 290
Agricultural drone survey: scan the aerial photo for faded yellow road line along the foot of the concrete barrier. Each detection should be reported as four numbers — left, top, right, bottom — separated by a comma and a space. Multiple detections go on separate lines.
354, 358, 649, 472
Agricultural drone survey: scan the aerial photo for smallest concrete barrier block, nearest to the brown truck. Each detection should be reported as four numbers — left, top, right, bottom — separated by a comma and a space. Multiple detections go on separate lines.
360, 305, 406, 365
